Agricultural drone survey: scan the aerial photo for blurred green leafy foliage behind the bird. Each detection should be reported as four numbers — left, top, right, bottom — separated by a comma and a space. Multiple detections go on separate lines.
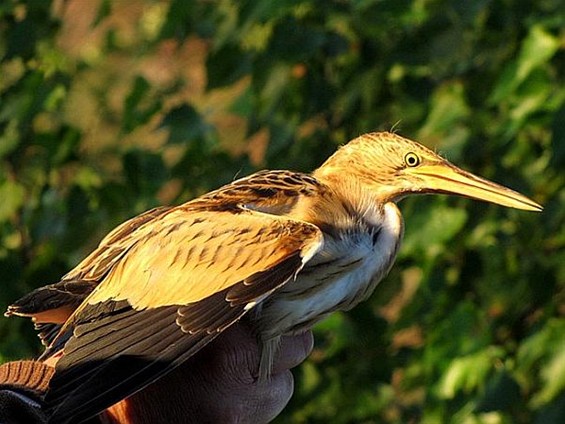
0, 0, 565, 424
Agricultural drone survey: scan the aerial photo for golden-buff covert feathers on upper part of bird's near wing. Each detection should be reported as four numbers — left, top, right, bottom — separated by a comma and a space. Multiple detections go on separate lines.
81, 209, 321, 309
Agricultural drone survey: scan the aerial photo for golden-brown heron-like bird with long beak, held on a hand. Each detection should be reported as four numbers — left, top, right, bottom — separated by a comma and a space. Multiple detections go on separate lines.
6, 132, 542, 423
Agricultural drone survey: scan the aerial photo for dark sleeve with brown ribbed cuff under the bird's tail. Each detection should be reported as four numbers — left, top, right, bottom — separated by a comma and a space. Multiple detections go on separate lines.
0, 361, 54, 424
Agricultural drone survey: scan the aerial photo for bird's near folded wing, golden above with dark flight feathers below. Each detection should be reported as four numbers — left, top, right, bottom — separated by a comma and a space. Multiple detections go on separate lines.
46, 205, 323, 423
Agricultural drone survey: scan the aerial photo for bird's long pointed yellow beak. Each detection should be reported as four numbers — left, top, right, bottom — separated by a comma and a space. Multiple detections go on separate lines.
410, 161, 543, 211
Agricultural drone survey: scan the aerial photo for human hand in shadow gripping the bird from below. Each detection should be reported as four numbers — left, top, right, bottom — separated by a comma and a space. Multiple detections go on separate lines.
103, 323, 314, 424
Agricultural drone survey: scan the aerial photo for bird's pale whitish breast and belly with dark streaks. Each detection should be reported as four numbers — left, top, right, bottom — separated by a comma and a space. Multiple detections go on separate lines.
260, 203, 403, 338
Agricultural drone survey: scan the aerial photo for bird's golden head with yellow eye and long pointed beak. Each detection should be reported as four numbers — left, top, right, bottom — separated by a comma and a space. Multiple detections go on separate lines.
316, 132, 542, 211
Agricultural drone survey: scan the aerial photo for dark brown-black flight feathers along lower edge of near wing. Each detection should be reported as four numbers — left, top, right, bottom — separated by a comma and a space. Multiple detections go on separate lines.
45, 252, 302, 424
